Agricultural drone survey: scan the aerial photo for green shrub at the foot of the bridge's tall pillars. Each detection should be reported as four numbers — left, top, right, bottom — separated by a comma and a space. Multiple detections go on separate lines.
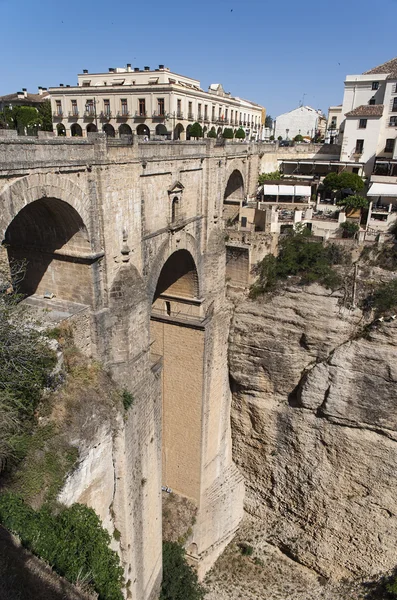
160, 542, 205, 600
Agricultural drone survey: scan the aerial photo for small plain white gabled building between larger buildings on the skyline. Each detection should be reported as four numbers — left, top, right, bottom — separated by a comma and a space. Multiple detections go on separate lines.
273, 106, 326, 140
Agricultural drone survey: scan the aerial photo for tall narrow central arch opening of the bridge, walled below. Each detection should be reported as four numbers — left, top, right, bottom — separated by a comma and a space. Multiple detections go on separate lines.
150, 250, 204, 502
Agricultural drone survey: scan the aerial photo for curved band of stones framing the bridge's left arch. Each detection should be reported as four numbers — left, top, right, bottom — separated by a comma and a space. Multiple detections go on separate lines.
0, 173, 93, 243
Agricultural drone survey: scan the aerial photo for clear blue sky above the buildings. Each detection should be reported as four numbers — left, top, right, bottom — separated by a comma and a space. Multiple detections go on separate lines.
0, 0, 397, 117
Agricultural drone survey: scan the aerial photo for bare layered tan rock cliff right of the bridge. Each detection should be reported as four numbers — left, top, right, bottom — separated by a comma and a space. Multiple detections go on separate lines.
229, 286, 397, 578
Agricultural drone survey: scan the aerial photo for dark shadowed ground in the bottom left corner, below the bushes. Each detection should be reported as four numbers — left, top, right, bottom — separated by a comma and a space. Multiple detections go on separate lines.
0, 526, 92, 600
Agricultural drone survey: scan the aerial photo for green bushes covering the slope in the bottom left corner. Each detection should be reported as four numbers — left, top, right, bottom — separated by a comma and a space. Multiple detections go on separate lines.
0, 493, 123, 600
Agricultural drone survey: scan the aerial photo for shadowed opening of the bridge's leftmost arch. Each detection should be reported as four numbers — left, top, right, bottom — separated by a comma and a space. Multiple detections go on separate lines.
3, 198, 93, 305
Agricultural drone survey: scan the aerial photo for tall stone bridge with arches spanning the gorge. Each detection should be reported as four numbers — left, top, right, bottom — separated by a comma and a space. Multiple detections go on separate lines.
0, 134, 260, 600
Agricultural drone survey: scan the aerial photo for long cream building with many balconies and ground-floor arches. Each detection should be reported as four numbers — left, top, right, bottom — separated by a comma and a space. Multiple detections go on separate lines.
50, 64, 265, 140
